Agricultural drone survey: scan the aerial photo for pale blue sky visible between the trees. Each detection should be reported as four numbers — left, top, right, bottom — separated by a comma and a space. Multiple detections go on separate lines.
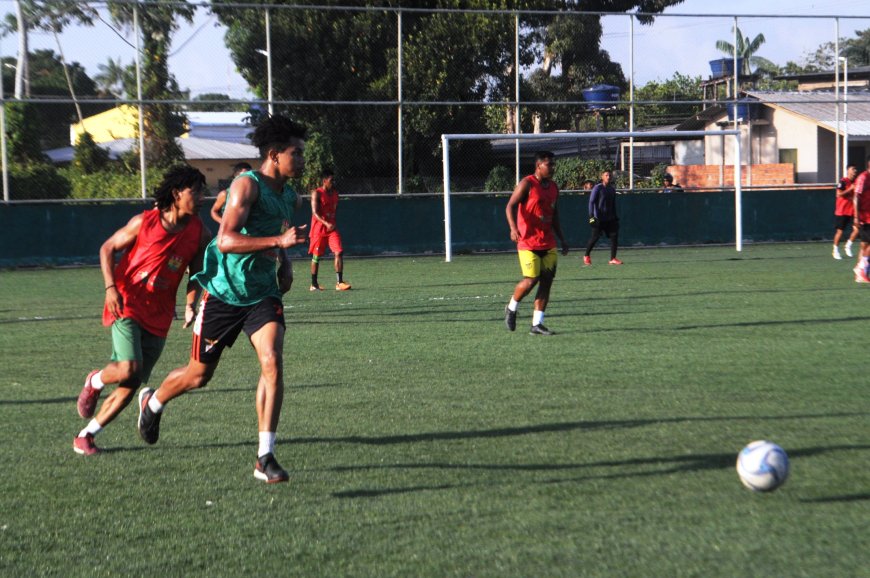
0, 0, 870, 99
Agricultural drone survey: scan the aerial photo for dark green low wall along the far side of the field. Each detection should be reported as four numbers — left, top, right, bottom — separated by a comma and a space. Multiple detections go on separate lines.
0, 189, 834, 267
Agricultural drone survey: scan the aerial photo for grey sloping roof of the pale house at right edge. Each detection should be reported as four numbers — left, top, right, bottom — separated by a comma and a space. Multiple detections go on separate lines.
745, 90, 870, 138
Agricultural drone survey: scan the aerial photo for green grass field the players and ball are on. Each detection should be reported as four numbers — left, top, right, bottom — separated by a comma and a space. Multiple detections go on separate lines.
0, 244, 870, 577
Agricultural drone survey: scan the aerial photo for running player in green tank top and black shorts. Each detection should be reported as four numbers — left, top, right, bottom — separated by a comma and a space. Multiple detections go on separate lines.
138, 115, 307, 483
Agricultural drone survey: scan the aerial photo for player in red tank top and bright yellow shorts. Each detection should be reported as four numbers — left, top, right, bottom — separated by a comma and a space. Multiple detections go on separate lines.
504, 151, 568, 335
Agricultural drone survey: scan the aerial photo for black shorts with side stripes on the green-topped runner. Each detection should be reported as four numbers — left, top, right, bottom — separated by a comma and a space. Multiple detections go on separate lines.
190, 292, 285, 363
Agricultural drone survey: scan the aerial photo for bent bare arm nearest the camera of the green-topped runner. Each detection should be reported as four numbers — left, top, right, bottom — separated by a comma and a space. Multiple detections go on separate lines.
218, 173, 306, 253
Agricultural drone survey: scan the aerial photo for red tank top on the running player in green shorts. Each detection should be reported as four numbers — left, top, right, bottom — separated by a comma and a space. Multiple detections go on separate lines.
103, 209, 202, 337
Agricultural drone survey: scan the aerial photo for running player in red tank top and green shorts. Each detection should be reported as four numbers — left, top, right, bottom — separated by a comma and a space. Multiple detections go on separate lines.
73, 166, 211, 456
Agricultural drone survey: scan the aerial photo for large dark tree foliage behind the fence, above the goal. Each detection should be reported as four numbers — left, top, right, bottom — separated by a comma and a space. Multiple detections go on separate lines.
212, 0, 682, 181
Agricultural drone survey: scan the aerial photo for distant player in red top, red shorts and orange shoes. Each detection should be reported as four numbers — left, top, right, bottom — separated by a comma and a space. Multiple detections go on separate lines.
308, 168, 351, 291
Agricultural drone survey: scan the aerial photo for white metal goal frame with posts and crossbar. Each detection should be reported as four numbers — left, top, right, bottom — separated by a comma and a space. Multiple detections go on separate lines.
441, 129, 743, 263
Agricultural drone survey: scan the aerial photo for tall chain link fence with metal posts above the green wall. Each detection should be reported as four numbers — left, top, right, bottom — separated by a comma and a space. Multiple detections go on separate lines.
0, 2, 870, 202
